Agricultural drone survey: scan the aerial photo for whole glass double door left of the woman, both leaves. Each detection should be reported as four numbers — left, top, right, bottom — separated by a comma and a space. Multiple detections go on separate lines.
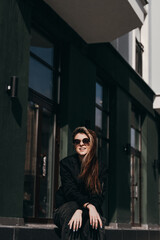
24, 102, 56, 218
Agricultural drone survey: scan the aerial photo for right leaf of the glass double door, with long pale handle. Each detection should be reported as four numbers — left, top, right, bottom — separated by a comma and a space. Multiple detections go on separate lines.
35, 105, 55, 218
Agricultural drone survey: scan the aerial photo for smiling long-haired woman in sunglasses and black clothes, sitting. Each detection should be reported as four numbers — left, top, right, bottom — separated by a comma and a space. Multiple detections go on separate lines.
54, 127, 106, 240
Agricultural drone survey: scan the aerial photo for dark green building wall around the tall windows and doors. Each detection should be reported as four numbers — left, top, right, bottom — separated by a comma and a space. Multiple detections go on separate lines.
0, 0, 159, 227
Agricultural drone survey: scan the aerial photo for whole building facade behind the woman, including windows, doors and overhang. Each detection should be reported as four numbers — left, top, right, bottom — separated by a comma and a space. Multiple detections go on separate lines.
0, 0, 160, 237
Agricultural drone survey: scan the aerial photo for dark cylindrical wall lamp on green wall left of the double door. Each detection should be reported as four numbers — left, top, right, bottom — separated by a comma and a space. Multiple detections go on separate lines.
7, 76, 18, 98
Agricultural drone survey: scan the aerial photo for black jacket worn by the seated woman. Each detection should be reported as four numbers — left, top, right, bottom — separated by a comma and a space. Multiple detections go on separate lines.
56, 154, 107, 214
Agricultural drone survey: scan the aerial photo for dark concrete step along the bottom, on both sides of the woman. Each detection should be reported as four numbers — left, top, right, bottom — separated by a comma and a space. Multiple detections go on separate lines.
0, 224, 160, 240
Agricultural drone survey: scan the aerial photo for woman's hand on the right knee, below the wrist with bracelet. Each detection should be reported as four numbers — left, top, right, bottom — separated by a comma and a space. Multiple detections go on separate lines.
87, 204, 102, 229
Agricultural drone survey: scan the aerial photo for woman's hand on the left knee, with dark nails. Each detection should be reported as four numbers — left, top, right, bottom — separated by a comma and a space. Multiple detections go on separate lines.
68, 209, 82, 232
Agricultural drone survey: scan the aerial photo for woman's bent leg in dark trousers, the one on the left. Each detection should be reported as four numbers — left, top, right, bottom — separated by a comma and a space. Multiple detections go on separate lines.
53, 201, 80, 240
